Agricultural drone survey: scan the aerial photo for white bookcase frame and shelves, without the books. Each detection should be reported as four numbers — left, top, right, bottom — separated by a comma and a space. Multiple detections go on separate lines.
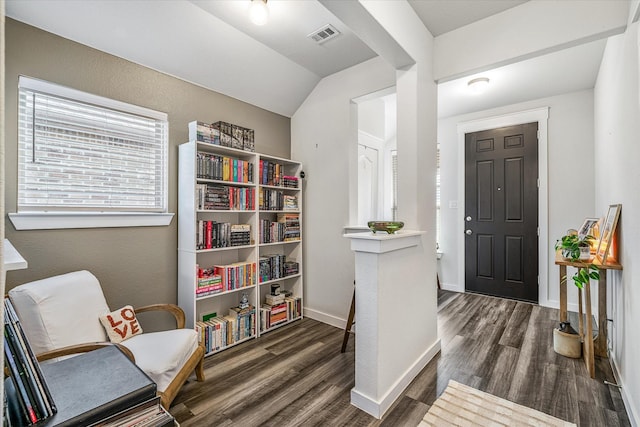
178, 135, 303, 355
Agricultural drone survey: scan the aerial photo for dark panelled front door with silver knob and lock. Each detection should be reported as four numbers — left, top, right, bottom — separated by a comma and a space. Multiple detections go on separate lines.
465, 123, 538, 302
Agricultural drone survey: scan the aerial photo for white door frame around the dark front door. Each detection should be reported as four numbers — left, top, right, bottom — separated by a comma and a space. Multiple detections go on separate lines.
456, 107, 549, 306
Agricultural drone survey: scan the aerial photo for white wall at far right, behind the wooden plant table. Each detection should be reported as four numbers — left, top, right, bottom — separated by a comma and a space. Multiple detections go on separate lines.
594, 23, 640, 425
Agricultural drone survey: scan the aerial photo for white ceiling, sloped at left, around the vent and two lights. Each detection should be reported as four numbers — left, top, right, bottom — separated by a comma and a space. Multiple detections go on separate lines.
6, 0, 604, 117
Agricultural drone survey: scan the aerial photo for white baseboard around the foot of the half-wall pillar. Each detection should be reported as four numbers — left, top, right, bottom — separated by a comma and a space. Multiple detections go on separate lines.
351, 339, 440, 419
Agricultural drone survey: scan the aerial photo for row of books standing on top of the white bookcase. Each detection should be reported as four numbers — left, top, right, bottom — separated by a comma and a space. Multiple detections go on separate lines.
189, 121, 255, 152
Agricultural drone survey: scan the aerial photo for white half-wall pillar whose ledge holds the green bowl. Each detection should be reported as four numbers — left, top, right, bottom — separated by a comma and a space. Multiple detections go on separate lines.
345, 231, 440, 418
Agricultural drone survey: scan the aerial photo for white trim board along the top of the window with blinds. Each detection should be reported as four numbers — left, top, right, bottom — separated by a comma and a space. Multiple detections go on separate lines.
18, 76, 168, 122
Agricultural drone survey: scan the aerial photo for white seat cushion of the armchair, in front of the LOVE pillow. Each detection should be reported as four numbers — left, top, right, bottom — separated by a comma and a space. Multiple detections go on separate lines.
122, 329, 198, 392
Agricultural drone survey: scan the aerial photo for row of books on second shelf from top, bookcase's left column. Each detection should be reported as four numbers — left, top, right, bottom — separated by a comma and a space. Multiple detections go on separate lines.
196, 184, 255, 211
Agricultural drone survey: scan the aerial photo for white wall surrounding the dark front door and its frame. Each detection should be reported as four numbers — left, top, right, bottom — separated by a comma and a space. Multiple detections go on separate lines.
438, 90, 606, 311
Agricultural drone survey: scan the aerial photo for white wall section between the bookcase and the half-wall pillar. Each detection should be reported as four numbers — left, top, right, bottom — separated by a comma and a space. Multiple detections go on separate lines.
291, 57, 395, 327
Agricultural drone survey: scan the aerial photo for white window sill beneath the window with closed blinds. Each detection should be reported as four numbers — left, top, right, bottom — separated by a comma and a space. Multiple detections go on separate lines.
8, 212, 174, 230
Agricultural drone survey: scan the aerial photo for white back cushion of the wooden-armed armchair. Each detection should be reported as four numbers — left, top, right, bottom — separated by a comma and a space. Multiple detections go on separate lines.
9, 271, 111, 354
